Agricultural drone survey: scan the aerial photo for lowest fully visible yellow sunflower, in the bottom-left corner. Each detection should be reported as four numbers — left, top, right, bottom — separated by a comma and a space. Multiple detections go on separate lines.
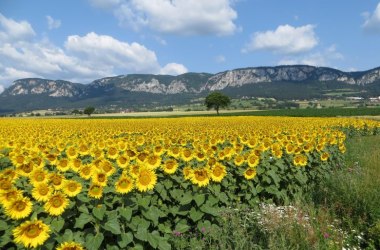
13, 220, 50, 248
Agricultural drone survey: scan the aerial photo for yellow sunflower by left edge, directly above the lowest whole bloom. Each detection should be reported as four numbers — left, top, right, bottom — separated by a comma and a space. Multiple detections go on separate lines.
5, 197, 33, 220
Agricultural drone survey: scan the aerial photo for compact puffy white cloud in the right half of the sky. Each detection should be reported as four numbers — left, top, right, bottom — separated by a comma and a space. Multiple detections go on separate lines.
243, 24, 318, 54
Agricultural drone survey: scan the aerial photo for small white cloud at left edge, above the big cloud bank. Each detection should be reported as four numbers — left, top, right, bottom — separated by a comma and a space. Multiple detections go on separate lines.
0, 13, 36, 43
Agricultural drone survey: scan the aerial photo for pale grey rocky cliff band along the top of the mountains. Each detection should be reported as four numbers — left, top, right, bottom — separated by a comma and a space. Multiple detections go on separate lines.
0, 65, 380, 97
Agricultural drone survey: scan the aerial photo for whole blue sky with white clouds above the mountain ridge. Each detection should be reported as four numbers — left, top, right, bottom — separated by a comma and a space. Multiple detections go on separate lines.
0, 0, 380, 92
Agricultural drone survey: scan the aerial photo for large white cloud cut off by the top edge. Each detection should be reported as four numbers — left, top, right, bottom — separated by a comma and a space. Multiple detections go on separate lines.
105, 0, 238, 35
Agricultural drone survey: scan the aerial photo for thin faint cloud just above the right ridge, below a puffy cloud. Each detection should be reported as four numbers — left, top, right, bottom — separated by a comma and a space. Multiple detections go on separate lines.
278, 45, 344, 67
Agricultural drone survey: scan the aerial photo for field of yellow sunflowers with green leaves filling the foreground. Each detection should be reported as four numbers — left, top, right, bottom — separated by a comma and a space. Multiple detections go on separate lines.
0, 117, 380, 249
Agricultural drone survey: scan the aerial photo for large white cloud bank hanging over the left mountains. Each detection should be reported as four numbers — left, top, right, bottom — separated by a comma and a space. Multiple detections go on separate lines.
0, 14, 187, 86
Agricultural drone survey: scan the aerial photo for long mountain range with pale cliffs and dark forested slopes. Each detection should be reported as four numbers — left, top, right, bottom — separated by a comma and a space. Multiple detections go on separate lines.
0, 65, 380, 113
